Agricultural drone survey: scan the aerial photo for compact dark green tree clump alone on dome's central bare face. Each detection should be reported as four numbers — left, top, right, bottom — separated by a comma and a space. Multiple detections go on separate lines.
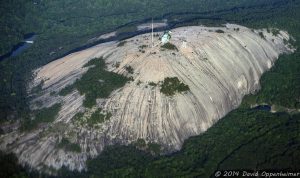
160, 77, 190, 96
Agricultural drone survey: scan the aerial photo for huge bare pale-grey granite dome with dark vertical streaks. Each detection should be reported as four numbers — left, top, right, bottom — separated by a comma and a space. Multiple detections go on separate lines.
0, 24, 293, 171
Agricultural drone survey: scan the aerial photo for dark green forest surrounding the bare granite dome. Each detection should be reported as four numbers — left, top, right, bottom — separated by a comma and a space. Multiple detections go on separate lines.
0, 0, 300, 177
